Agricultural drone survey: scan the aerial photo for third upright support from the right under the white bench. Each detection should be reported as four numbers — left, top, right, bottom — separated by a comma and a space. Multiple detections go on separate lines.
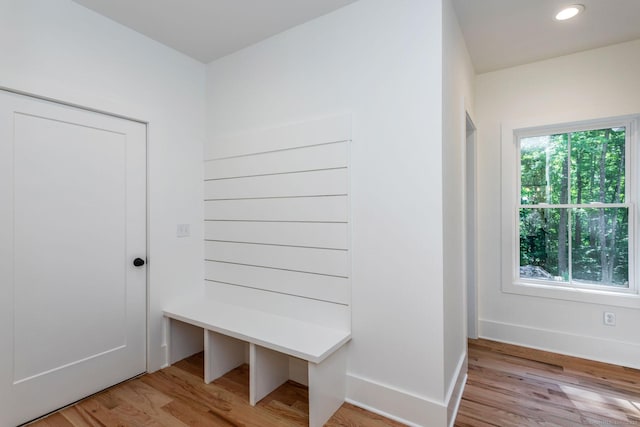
204, 329, 246, 384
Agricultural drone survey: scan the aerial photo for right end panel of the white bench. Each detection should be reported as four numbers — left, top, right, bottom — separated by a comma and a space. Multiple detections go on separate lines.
308, 346, 347, 427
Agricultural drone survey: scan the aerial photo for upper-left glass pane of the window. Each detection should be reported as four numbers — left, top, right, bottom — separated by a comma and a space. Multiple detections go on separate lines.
520, 134, 569, 205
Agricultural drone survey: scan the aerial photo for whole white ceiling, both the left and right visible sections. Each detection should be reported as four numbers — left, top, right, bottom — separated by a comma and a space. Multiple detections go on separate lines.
74, 0, 640, 73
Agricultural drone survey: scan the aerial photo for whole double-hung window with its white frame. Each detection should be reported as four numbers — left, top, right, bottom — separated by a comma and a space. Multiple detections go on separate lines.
503, 117, 638, 306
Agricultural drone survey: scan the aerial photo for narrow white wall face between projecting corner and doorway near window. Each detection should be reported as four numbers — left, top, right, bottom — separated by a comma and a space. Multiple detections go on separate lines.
442, 0, 475, 422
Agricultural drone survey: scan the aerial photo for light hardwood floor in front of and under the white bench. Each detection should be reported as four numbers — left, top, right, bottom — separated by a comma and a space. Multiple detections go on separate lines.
26, 353, 402, 427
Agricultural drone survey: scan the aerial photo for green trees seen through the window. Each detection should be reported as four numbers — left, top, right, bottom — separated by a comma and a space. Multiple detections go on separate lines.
518, 127, 629, 288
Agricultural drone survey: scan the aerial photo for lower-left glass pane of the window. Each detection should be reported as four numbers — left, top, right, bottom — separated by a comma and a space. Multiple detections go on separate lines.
520, 208, 569, 282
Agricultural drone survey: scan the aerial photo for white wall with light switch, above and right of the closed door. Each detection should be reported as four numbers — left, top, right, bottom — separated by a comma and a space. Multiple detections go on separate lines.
0, 0, 205, 371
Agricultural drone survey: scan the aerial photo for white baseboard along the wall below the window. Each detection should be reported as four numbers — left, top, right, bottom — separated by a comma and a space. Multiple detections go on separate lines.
479, 320, 640, 369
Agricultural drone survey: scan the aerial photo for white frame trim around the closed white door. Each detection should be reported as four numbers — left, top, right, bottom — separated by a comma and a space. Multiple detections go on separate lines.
0, 85, 151, 372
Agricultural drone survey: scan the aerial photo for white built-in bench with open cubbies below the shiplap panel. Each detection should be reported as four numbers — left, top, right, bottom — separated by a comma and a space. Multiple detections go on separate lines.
164, 299, 351, 427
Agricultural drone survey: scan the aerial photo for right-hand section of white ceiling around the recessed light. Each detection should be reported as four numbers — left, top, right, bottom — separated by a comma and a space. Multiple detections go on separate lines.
453, 0, 640, 73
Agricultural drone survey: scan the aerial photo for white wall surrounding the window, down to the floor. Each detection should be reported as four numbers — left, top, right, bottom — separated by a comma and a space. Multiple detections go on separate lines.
476, 40, 640, 368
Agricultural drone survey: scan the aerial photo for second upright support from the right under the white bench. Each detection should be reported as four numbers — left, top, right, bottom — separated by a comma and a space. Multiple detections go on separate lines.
249, 343, 289, 406
